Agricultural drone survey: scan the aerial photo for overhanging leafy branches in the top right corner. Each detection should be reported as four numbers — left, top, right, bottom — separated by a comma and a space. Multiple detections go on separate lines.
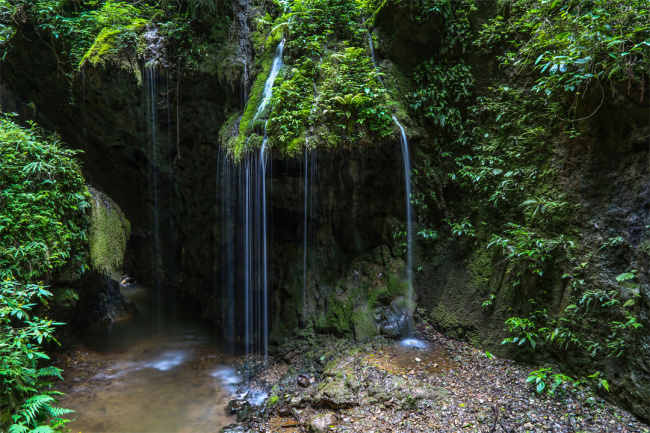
481, 0, 650, 113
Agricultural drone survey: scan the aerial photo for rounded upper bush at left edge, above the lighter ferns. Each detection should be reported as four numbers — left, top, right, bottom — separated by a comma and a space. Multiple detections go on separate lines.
0, 114, 89, 281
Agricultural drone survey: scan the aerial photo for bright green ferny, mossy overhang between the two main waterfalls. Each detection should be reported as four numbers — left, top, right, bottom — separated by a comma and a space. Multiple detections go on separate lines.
226, 0, 395, 159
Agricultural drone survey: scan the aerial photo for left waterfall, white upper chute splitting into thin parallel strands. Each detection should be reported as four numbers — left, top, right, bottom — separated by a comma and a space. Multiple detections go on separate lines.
215, 40, 284, 363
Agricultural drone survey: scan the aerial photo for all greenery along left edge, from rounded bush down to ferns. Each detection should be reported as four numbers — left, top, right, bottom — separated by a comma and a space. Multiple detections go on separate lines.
0, 117, 89, 432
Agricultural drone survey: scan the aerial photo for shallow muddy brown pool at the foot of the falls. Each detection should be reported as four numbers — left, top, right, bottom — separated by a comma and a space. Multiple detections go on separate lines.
59, 286, 234, 433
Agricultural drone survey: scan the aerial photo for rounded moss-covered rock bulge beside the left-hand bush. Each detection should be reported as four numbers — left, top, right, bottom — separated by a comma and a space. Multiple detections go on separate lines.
88, 188, 131, 274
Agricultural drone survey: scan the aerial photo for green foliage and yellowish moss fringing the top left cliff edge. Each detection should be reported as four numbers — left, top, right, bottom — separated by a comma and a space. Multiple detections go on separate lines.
0, 0, 230, 74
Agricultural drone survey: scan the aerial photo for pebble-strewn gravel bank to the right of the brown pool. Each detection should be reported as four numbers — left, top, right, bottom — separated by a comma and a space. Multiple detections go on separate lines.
221, 323, 650, 433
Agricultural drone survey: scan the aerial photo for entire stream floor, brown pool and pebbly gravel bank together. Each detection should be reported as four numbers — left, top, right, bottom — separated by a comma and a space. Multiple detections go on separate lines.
48, 306, 650, 433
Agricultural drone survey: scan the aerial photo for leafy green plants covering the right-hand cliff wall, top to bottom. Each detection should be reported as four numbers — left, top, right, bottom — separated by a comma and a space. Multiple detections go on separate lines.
410, 0, 650, 393
